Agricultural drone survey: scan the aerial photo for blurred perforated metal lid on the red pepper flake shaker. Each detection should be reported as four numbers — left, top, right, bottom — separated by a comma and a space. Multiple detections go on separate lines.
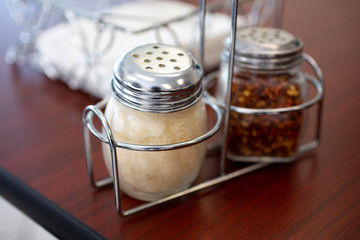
223, 27, 303, 70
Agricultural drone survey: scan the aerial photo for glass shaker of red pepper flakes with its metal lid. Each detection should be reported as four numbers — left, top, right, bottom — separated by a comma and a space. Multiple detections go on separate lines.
217, 27, 307, 162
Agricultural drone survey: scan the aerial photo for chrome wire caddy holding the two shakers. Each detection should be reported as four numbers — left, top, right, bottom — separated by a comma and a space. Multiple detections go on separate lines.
83, 0, 324, 216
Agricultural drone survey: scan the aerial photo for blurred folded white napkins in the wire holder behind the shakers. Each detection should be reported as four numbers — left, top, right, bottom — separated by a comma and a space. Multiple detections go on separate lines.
36, 0, 245, 98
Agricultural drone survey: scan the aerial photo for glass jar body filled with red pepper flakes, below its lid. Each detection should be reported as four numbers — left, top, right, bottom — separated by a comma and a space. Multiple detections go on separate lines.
217, 62, 307, 162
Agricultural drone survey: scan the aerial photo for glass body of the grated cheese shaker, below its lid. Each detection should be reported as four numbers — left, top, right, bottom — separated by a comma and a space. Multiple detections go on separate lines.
103, 98, 207, 201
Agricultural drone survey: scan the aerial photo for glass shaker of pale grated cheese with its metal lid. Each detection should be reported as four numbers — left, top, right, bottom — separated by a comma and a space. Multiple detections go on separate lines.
103, 44, 207, 201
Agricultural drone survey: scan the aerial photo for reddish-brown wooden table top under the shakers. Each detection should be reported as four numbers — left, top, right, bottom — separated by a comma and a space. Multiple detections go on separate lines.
0, 0, 360, 239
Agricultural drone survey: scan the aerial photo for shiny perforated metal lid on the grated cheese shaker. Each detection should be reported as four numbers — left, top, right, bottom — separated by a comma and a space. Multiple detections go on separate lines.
111, 44, 203, 113
